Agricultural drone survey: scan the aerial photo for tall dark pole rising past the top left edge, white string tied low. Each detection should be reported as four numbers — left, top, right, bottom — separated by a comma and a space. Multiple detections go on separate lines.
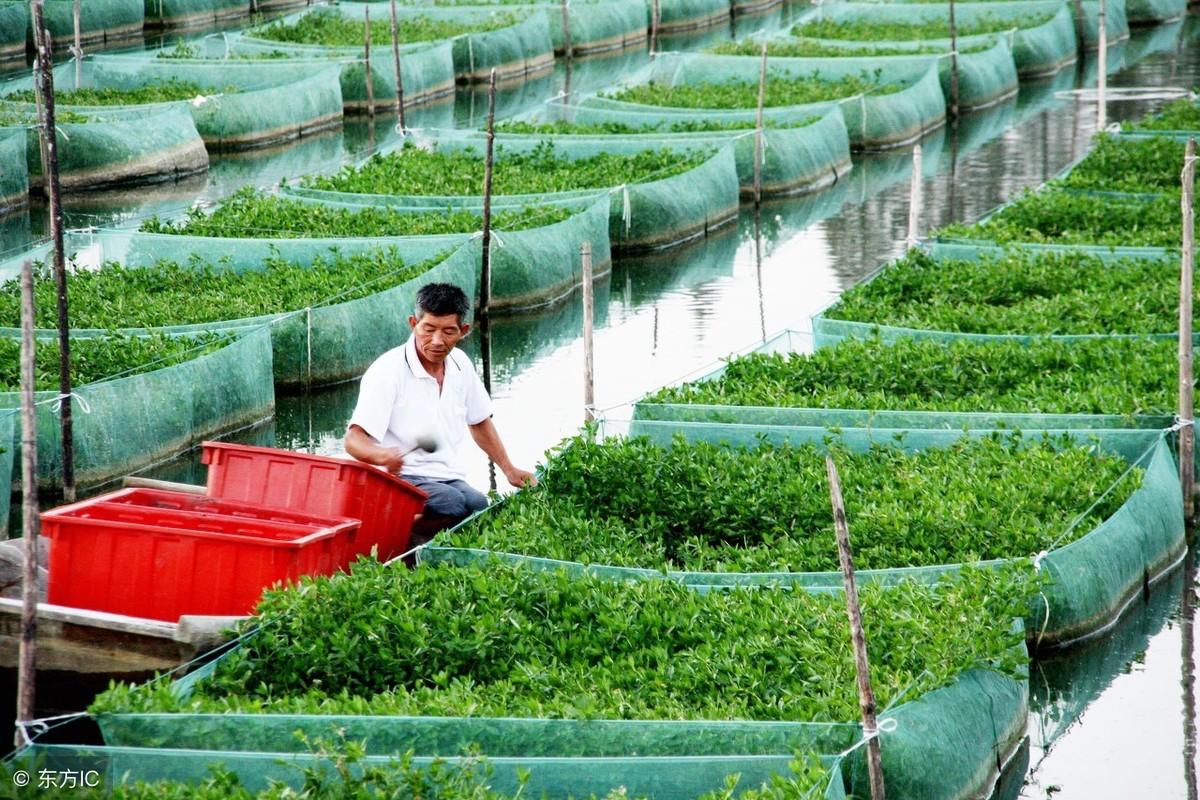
31, 0, 76, 503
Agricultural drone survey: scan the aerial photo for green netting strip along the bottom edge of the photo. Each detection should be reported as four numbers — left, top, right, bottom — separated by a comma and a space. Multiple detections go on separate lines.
14, 745, 846, 800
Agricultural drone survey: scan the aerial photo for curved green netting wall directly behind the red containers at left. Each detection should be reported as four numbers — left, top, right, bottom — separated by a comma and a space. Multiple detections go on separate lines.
0, 327, 275, 486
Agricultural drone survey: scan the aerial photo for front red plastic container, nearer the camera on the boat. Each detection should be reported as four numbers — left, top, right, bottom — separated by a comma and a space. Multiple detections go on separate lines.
41, 489, 359, 622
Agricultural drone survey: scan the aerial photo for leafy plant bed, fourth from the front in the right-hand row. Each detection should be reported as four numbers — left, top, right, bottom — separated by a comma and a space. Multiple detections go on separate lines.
814, 249, 1180, 339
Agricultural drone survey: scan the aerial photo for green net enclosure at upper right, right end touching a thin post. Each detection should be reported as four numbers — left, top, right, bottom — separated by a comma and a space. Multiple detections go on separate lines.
595, 53, 946, 150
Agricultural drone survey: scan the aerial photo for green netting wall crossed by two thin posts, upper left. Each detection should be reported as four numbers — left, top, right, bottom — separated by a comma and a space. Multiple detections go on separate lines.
227, 34, 455, 112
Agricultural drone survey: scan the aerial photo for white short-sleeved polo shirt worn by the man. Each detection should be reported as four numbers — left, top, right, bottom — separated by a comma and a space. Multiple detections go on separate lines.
349, 338, 492, 480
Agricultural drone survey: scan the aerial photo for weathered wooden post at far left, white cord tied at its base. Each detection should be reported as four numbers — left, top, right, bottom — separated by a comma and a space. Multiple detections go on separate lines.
16, 260, 41, 746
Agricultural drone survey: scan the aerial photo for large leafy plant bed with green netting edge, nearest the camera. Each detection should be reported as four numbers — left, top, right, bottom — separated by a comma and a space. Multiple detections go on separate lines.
92, 561, 1037, 798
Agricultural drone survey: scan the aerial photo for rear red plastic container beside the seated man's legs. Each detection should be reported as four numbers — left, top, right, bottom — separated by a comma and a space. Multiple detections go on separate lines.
202, 441, 427, 559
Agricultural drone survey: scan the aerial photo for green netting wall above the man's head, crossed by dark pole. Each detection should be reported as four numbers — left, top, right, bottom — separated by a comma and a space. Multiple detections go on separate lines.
94, 197, 612, 311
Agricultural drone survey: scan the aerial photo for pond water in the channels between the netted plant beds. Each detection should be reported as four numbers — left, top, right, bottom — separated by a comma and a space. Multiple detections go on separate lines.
0, 8, 1200, 799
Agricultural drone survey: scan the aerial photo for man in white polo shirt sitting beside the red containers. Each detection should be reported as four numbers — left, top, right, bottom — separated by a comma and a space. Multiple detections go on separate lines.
346, 283, 536, 546
